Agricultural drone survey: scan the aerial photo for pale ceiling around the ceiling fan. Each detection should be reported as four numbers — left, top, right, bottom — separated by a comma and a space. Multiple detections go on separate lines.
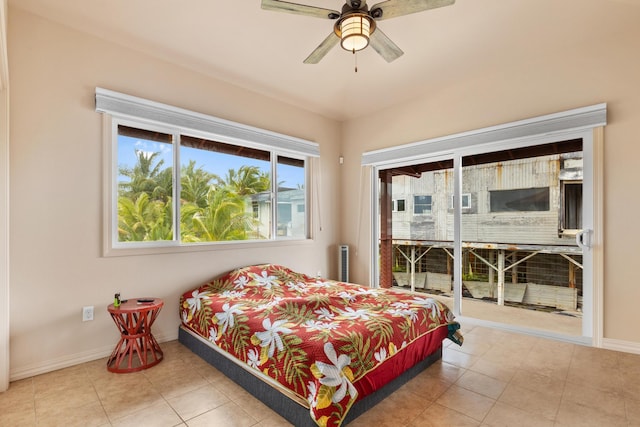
9, 0, 640, 120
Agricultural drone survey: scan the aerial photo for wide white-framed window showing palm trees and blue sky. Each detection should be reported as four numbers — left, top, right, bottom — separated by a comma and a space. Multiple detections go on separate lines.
96, 89, 318, 250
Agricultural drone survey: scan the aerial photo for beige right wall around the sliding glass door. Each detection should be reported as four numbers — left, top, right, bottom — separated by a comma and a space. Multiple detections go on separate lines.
342, 22, 640, 348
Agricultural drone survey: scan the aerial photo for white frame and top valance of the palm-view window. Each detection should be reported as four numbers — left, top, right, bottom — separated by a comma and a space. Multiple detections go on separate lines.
96, 88, 320, 256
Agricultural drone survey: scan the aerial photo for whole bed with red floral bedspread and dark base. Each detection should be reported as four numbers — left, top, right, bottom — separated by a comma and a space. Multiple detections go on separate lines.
179, 264, 462, 427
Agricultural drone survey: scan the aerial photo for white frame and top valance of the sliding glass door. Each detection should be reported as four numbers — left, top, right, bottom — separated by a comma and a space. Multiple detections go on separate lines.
362, 104, 606, 347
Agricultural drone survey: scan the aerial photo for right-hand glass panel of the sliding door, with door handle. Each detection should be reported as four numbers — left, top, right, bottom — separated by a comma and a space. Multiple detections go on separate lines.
460, 139, 585, 337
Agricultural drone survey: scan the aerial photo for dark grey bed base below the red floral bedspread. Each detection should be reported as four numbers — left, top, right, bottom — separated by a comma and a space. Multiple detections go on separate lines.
178, 327, 442, 427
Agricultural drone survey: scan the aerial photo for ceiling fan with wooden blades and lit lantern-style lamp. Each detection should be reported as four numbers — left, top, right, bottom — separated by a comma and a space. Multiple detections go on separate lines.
262, 0, 455, 64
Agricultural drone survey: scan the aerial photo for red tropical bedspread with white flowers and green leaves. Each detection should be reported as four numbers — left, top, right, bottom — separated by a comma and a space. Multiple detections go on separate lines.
180, 264, 459, 426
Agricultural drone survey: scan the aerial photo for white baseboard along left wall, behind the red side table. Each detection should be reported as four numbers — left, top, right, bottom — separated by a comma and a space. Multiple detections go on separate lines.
9, 330, 178, 381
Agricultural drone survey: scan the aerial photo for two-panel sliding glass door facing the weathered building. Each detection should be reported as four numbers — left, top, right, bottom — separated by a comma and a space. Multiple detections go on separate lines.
374, 133, 593, 341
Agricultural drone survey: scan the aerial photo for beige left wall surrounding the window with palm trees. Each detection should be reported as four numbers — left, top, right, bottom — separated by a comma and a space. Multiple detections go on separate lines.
8, 10, 341, 378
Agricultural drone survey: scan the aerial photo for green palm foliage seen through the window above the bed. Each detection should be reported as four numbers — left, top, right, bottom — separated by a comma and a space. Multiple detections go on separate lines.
118, 151, 271, 243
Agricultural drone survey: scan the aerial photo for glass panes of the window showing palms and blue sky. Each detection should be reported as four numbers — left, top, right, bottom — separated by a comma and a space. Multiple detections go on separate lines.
117, 124, 306, 244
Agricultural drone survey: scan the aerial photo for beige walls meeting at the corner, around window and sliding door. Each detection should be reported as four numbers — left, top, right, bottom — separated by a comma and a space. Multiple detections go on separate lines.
8, 2, 640, 378
